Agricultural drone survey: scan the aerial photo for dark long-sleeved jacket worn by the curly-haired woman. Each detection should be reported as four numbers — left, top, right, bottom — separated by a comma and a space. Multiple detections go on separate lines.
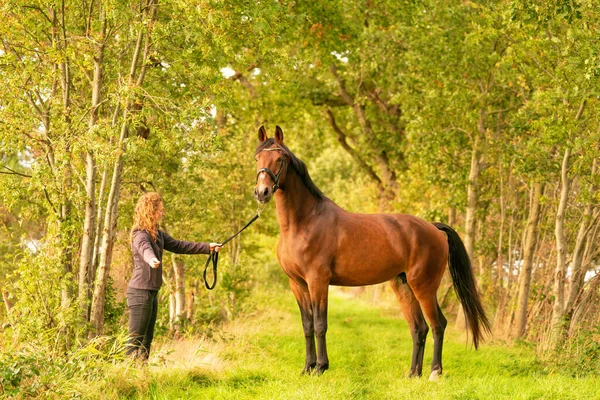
129, 229, 210, 290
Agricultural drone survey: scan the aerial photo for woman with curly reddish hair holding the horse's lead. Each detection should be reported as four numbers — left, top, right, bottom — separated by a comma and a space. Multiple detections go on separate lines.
126, 192, 221, 362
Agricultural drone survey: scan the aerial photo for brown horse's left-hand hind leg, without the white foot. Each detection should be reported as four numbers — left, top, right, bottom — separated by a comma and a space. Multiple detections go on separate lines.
390, 276, 429, 377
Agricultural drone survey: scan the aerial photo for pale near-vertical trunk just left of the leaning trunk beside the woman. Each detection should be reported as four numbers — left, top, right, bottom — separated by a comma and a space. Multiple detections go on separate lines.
79, 11, 106, 321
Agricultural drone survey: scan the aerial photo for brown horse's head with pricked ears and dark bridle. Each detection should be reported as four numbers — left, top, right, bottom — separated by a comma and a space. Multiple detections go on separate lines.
254, 126, 289, 203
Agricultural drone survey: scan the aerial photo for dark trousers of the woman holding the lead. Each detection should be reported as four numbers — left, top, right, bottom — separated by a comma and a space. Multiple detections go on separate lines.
126, 287, 158, 361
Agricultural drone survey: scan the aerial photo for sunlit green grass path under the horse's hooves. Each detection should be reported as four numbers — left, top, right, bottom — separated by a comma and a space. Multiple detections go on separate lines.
88, 291, 600, 400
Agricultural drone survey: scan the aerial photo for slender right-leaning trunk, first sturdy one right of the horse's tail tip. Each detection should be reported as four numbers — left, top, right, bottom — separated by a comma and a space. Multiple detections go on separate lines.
512, 182, 544, 338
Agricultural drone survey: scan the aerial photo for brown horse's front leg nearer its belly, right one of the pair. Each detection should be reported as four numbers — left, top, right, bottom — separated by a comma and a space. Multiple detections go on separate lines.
308, 276, 329, 375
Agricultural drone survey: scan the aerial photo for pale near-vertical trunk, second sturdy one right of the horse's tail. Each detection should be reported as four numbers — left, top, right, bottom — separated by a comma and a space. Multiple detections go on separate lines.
550, 147, 571, 348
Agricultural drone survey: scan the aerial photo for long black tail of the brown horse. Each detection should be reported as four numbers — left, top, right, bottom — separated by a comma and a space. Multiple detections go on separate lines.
433, 223, 491, 348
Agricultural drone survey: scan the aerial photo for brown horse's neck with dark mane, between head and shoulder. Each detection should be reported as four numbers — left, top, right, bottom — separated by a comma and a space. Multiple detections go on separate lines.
275, 170, 320, 231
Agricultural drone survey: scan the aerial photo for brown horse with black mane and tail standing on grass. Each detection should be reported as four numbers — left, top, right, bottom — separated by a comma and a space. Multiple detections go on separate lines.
254, 127, 489, 380
